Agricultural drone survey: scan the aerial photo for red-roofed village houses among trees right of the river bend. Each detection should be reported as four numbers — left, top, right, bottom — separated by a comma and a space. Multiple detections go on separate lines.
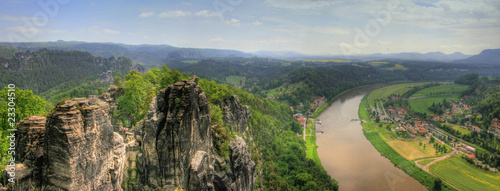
371, 95, 500, 172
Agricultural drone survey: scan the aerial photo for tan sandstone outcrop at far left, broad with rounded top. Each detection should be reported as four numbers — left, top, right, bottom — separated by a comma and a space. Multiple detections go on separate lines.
8, 98, 125, 190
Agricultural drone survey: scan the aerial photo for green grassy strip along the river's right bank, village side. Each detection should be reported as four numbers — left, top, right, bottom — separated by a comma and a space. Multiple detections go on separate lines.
358, 94, 455, 190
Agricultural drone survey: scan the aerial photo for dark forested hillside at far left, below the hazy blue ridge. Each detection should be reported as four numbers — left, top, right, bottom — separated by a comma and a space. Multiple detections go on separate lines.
0, 47, 145, 101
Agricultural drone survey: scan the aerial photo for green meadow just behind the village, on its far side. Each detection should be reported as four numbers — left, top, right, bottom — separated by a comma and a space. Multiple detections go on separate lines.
408, 94, 460, 115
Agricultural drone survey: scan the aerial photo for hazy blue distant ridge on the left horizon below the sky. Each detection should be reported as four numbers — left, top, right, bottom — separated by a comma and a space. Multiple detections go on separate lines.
0, 41, 253, 67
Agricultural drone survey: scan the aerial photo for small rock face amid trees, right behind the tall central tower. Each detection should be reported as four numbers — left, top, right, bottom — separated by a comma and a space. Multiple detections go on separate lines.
222, 95, 251, 134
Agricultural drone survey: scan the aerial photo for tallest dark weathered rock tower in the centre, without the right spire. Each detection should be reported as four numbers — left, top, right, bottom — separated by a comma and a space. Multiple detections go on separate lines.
136, 78, 212, 189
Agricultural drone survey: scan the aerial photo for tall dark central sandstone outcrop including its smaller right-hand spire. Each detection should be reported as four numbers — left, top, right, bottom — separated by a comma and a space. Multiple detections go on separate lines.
135, 78, 255, 190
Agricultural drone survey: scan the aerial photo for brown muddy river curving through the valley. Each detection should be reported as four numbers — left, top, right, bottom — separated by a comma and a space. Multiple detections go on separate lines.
316, 86, 426, 191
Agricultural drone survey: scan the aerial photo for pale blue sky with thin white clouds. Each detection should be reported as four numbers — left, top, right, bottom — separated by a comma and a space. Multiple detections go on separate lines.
0, 0, 500, 55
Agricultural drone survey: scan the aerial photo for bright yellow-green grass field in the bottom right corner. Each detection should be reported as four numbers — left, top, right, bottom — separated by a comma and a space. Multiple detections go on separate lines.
430, 155, 500, 190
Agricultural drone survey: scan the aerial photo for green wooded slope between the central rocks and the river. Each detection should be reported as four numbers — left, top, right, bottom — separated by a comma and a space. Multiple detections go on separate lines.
204, 83, 338, 190
